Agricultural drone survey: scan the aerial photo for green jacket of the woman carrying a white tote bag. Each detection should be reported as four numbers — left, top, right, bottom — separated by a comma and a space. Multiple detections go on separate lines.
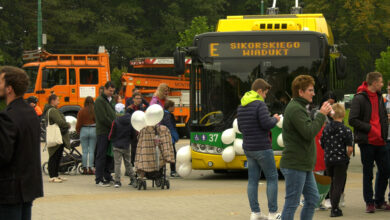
43, 104, 70, 156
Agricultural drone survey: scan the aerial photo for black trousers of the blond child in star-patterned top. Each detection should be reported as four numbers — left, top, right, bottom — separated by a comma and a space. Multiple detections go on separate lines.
326, 163, 348, 209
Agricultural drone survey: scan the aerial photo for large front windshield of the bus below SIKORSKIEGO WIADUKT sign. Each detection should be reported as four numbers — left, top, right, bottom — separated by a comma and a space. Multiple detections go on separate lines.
191, 58, 325, 130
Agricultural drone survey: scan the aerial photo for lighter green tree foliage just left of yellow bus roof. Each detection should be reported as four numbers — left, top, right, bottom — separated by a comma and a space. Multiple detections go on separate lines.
177, 16, 214, 47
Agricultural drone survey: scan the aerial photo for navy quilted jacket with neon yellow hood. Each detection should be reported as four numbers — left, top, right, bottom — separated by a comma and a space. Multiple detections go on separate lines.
237, 91, 278, 151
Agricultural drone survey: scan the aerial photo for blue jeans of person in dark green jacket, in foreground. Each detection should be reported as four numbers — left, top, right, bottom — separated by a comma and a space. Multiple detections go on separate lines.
281, 168, 320, 220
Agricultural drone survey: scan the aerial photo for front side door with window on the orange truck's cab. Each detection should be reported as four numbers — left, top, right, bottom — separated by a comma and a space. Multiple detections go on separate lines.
39, 67, 69, 106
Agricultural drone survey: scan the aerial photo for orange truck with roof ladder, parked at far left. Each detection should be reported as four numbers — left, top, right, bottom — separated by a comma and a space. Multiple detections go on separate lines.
23, 46, 110, 117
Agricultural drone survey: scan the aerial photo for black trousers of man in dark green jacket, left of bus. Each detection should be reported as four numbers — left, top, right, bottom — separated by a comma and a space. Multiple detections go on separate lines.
95, 134, 114, 183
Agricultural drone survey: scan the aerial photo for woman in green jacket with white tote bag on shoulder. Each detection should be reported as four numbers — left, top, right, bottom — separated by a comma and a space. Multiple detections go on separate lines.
43, 94, 70, 183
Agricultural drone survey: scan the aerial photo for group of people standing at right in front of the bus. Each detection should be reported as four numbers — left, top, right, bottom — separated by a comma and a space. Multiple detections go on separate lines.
237, 72, 390, 220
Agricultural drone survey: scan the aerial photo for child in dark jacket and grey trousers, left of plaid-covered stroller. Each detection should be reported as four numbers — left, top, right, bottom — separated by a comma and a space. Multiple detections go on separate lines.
109, 109, 136, 188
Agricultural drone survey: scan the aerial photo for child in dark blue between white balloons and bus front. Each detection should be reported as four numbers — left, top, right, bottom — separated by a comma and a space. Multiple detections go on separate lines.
161, 100, 179, 177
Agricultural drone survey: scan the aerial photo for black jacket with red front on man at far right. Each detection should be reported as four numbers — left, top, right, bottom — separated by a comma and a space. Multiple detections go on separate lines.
348, 82, 388, 146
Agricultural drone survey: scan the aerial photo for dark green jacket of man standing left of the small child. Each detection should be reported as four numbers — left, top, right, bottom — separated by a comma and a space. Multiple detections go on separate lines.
95, 94, 116, 135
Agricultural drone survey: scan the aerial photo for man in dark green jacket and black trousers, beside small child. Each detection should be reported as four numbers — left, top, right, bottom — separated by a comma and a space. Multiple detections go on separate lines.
95, 82, 116, 186
